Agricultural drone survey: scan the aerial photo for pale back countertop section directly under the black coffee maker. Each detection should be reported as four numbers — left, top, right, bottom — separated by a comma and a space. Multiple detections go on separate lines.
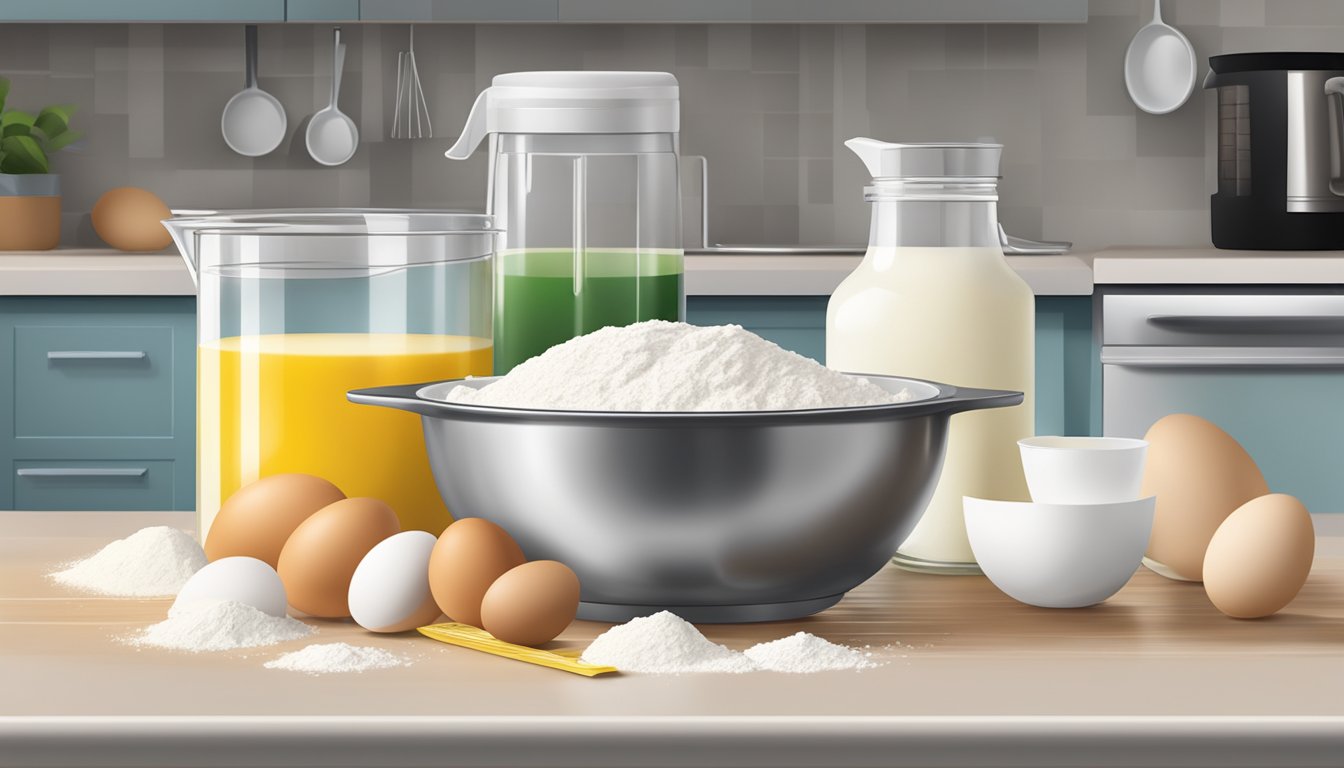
1091, 247, 1344, 285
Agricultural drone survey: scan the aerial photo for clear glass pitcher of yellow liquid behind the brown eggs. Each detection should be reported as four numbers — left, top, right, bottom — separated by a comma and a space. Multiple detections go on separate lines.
164, 211, 497, 538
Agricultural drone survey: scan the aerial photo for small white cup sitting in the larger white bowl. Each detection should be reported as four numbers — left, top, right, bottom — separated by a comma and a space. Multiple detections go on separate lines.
1017, 437, 1148, 504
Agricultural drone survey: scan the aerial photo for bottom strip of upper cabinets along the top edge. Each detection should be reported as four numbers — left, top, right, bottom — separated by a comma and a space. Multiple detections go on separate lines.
0, 0, 1087, 24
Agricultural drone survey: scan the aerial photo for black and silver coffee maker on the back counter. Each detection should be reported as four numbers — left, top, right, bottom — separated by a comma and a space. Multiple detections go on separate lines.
1204, 52, 1344, 250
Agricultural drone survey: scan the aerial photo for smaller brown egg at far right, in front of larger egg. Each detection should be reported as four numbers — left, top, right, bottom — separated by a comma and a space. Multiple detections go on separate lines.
1204, 494, 1316, 619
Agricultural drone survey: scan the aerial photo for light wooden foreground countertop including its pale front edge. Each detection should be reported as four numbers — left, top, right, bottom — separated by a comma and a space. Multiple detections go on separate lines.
0, 512, 1344, 768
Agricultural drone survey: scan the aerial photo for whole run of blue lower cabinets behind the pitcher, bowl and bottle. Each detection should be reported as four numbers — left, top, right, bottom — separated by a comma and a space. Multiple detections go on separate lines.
0, 296, 1101, 510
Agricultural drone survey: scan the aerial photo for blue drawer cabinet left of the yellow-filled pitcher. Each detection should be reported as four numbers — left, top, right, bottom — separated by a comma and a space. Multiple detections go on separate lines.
0, 296, 196, 510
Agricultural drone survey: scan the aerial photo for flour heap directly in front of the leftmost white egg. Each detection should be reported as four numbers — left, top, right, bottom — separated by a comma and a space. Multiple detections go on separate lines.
130, 601, 316, 654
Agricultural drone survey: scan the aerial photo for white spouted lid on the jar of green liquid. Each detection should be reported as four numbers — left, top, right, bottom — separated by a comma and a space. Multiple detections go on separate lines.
446, 71, 680, 160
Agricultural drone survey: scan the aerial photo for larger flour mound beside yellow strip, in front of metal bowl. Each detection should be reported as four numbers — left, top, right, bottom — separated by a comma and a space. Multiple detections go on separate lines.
582, 611, 755, 675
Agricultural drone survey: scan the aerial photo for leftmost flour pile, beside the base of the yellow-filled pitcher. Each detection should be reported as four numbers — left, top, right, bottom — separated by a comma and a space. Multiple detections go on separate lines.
50, 526, 206, 597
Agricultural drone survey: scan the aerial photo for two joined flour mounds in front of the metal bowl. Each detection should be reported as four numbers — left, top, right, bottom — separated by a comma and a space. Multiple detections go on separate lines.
582, 611, 878, 675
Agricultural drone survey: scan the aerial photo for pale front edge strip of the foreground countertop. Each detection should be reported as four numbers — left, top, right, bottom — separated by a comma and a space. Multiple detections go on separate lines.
0, 716, 1344, 768
